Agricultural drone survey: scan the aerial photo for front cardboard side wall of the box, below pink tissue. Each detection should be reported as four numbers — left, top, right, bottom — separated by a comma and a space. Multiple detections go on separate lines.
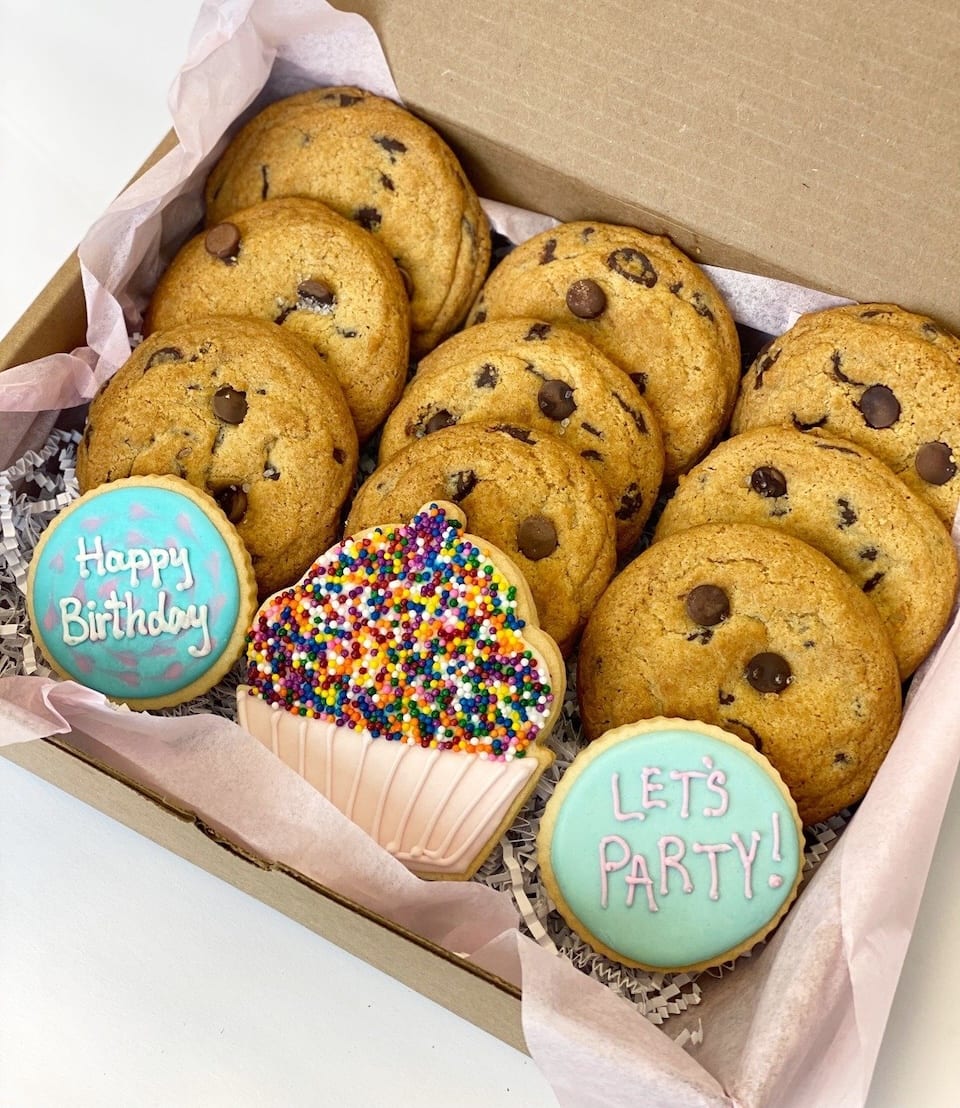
0, 739, 527, 1053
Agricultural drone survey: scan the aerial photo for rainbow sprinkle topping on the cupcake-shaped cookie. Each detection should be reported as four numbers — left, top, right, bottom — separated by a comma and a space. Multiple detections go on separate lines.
247, 504, 553, 761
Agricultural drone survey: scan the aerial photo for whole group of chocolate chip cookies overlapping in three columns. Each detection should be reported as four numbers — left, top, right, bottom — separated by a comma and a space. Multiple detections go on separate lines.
61, 88, 960, 944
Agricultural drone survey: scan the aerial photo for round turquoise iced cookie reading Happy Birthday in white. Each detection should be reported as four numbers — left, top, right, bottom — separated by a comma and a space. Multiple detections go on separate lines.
27, 476, 257, 708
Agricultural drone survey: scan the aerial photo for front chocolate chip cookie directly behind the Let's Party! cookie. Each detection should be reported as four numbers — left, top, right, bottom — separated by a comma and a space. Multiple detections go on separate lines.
578, 523, 900, 823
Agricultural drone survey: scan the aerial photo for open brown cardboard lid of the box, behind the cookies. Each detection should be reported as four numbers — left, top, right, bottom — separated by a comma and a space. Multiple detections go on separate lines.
337, 0, 960, 330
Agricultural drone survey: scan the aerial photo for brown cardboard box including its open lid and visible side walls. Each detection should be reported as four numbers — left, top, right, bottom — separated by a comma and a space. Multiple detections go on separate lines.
0, 0, 960, 1103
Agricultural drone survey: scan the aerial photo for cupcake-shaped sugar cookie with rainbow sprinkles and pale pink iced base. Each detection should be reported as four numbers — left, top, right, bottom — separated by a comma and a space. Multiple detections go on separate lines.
237, 503, 564, 879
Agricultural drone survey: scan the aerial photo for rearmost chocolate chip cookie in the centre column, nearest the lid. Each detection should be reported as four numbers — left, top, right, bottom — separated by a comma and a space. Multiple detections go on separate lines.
467, 222, 741, 478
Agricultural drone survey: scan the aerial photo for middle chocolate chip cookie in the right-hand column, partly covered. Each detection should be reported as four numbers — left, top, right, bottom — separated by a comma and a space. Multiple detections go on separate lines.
655, 427, 957, 677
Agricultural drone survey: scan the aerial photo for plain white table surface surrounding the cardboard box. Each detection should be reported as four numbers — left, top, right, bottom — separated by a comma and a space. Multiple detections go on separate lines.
0, 0, 960, 1108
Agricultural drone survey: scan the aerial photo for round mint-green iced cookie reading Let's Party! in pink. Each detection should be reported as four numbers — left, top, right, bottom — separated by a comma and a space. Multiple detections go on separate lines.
537, 718, 804, 973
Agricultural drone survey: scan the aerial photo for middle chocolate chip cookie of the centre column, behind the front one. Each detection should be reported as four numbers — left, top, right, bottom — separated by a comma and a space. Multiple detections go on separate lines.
380, 319, 663, 552
